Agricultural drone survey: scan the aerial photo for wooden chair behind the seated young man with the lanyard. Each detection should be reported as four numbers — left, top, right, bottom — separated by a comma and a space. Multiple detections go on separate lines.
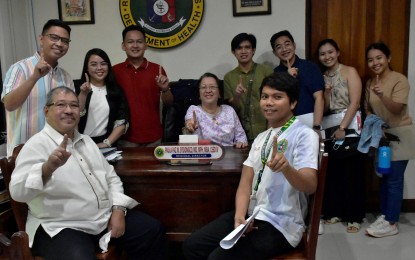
271, 146, 329, 260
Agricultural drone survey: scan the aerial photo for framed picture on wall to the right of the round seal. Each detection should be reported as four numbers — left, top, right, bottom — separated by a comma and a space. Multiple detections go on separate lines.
232, 0, 271, 16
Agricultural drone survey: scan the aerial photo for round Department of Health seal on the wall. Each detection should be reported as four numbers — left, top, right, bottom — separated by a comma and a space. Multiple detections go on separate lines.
120, 0, 204, 49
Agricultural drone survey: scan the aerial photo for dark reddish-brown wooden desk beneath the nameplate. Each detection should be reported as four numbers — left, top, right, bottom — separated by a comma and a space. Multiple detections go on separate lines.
115, 147, 249, 241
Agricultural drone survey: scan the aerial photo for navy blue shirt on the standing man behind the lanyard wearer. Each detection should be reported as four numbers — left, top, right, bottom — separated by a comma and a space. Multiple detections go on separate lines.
274, 55, 324, 116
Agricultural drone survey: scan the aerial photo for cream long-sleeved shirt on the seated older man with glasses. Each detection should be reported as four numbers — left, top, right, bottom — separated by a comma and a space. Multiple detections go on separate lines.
10, 123, 138, 246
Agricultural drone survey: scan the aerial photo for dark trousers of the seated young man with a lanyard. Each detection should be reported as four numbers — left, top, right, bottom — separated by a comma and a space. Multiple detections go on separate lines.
183, 212, 293, 260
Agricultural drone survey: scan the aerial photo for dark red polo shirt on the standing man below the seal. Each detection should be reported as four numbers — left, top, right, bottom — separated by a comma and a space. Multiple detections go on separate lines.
113, 59, 166, 143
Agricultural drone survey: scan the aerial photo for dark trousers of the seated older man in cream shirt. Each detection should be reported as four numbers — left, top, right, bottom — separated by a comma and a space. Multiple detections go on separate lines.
32, 210, 166, 260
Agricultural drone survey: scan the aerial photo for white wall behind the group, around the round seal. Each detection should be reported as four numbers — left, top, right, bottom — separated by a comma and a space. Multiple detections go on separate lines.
29, 0, 305, 80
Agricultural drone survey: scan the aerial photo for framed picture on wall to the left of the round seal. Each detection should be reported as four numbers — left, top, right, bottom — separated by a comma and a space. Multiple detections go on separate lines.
58, 0, 95, 24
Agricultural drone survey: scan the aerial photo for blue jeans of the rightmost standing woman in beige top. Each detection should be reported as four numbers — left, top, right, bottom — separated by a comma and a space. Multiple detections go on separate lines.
380, 160, 408, 223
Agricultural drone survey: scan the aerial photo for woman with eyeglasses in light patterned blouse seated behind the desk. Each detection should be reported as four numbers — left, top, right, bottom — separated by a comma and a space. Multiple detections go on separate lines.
184, 73, 248, 148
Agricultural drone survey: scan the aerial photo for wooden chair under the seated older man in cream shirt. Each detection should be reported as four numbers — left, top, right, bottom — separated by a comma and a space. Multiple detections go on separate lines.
0, 144, 121, 260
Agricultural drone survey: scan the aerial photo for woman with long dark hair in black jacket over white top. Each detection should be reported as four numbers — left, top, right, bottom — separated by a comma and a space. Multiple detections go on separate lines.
74, 48, 129, 148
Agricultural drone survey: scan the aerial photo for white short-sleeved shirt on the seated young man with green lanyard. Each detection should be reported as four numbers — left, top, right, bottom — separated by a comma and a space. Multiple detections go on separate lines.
244, 119, 319, 247
